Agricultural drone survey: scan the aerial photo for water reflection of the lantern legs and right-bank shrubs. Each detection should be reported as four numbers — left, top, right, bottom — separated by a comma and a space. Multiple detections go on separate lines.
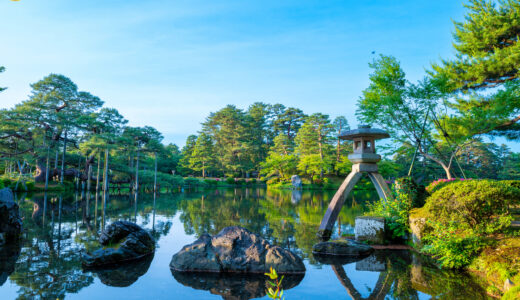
318, 250, 489, 300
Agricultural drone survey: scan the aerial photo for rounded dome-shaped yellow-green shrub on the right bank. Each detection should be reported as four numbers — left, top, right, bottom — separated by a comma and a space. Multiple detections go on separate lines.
425, 180, 520, 230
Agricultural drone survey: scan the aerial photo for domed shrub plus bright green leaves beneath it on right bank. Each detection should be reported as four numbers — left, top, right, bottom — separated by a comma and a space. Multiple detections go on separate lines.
422, 180, 520, 268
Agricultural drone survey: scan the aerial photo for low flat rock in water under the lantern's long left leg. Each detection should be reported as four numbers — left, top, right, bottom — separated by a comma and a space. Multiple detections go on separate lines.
312, 240, 374, 257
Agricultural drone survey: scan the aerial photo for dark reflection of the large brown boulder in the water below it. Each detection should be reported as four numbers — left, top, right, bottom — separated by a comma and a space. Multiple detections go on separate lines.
172, 270, 305, 300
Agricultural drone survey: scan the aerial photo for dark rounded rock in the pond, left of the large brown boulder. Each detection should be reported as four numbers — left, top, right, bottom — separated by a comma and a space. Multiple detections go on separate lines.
83, 221, 155, 267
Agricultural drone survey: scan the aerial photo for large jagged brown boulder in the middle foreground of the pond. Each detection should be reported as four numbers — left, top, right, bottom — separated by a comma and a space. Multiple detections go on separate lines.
170, 226, 305, 274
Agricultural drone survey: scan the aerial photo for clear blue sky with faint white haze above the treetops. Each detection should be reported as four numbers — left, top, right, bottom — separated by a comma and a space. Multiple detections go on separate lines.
0, 0, 516, 148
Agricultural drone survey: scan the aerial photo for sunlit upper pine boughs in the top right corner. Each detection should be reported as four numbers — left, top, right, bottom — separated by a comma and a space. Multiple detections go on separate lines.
433, 0, 520, 89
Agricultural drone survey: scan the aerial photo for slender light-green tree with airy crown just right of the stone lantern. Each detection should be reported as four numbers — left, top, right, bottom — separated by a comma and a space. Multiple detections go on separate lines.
356, 55, 474, 178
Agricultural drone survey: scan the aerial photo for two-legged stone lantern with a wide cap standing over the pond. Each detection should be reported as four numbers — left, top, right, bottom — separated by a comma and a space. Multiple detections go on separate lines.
318, 125, 392, 240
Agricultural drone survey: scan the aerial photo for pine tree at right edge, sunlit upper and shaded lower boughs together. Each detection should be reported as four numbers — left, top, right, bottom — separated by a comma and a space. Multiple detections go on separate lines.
432, 0, 520, 139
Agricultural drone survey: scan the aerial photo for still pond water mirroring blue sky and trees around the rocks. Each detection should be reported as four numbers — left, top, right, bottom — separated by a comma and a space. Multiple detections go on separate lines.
0, 189, 487, 300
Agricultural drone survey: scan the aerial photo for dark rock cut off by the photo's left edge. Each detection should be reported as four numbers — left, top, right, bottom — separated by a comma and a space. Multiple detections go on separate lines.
0, 188, 23, 245
